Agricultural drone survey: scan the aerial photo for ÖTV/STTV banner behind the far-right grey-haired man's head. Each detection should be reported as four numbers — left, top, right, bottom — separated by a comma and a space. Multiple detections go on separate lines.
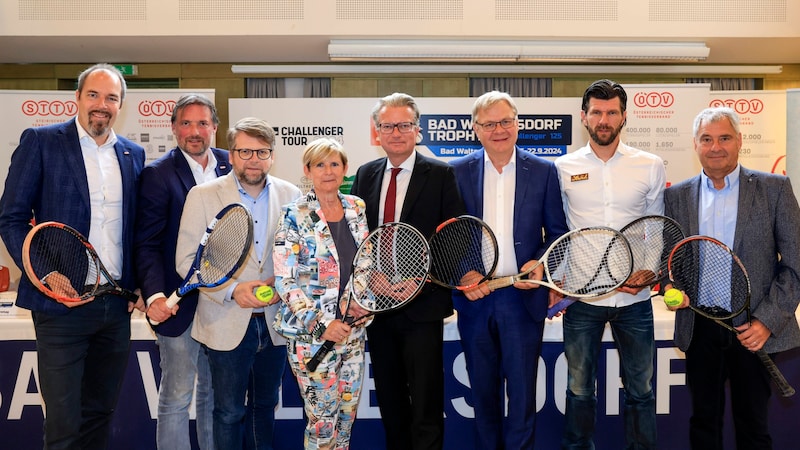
709, 91, 786, 175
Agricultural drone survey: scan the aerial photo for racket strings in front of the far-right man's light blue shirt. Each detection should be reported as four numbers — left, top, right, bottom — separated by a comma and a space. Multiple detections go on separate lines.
670, 239, 750, 319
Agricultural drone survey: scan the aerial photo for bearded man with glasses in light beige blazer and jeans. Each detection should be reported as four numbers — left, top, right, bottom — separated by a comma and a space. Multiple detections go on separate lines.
175, 117, 300, 450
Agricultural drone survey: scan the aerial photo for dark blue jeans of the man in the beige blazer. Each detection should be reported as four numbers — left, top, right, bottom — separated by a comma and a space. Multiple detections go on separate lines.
208, 316, 286, 450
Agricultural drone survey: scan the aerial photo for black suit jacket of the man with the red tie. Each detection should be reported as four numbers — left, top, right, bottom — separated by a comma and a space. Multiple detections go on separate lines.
350, 153, 464, 322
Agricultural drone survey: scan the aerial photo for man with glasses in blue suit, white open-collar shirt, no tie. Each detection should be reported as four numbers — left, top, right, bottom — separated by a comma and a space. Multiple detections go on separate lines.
451, 91, 567, 450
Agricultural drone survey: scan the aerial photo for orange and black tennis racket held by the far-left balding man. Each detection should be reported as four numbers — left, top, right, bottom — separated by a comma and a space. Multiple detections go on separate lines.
22, 222, 139, 303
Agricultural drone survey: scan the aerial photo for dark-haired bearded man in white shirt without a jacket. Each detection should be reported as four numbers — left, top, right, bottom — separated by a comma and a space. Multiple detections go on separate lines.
550, 80, 666, 449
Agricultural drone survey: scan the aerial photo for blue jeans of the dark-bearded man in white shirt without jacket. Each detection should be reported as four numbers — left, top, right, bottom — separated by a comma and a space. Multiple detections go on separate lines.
561, 301, 657, 449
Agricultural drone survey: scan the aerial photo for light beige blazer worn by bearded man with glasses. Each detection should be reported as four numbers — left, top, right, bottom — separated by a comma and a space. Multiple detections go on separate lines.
175, 172, 300, 351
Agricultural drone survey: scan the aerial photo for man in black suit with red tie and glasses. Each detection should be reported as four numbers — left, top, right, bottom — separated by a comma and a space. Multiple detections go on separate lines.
350, 93, 464, 450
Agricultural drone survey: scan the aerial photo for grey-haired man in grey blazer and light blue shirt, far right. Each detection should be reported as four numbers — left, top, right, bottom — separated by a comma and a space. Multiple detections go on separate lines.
664, 108, 800, 449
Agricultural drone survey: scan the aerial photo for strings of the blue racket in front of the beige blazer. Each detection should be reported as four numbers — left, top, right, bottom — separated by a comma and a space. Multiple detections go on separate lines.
197, 207, 251, 285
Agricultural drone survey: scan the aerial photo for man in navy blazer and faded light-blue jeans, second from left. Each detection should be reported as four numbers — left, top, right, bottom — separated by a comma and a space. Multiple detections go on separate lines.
135, 94, 231, 450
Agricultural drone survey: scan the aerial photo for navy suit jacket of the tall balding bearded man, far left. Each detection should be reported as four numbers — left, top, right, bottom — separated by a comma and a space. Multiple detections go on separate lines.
0, 119, 145, 314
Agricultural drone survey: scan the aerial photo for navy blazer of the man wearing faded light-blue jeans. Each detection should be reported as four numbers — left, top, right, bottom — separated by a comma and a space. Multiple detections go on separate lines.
134, 148, 231, 336
